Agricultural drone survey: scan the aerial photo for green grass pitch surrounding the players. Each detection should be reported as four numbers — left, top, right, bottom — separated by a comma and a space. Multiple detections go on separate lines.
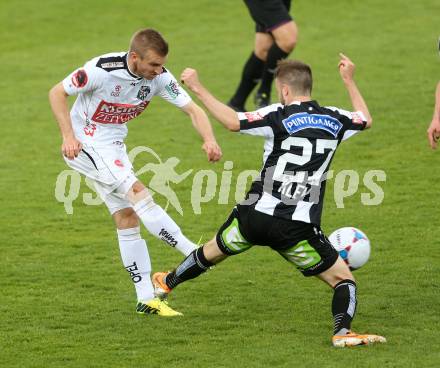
0, 0, 440, 368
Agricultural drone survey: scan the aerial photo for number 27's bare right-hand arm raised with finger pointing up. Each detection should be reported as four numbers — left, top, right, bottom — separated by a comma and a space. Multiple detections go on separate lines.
338, 53, 373, 128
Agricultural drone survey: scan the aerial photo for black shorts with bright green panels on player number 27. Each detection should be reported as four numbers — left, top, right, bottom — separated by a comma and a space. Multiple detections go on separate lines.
216, 205, 339, 276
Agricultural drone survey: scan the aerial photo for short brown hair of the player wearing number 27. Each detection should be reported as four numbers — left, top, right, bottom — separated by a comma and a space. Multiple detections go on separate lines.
275, 59, 313, 95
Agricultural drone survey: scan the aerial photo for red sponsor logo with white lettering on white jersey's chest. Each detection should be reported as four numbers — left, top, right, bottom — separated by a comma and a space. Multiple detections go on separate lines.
92, 101, 149, 124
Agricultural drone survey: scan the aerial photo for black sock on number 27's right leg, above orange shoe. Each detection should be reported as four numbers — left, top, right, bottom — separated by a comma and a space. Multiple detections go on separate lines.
332, 280, 357, 335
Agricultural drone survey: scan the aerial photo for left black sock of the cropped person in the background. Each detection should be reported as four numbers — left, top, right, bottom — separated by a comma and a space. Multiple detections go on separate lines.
230, 52, 264, 107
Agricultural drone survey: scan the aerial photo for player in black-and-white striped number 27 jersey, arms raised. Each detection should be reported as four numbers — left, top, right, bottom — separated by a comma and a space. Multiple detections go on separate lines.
153, 54, 386, 347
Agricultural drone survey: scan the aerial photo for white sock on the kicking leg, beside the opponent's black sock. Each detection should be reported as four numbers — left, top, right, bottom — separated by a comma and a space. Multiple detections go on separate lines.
133, 198, 197, 256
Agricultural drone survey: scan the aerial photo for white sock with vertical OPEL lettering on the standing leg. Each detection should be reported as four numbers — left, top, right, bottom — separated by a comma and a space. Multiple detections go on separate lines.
117, 227, 154, 301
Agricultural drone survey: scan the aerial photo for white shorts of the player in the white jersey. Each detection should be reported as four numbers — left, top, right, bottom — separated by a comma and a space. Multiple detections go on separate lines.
64, 144, 137, 214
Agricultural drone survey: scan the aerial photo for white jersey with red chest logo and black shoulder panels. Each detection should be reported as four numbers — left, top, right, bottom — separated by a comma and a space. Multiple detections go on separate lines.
63, 52, 191, 146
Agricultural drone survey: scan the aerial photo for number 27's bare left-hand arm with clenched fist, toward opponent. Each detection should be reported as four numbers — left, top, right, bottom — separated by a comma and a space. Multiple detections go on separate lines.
180, 68, 240, 132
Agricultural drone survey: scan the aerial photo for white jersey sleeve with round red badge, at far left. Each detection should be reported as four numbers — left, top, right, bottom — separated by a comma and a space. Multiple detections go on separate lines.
63, 59, 107, 96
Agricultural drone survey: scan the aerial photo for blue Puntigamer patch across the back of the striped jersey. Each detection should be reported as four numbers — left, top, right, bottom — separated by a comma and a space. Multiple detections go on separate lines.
283, 112, 342, 138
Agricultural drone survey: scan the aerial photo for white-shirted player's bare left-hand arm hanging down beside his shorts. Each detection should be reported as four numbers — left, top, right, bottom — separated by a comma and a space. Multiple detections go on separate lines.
49, 82, 82, 160
